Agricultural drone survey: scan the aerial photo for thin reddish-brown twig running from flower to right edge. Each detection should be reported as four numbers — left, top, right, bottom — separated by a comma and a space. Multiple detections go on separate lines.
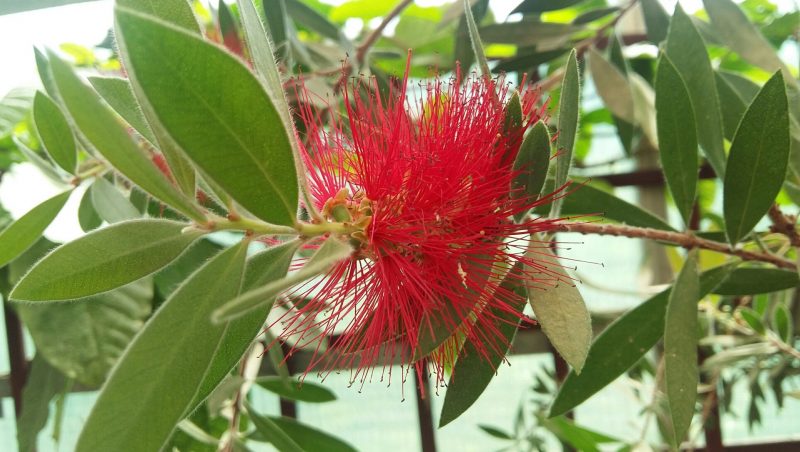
556, 223, 797, 270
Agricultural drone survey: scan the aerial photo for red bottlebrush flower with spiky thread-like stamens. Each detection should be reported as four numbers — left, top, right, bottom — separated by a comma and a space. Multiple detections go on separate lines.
276, 58, 566, 382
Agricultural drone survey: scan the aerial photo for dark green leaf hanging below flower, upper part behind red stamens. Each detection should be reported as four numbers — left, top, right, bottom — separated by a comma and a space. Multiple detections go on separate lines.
439, 264, 525, 428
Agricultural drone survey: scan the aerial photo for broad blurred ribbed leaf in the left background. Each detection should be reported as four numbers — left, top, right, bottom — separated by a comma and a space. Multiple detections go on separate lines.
16, 278, 153, 387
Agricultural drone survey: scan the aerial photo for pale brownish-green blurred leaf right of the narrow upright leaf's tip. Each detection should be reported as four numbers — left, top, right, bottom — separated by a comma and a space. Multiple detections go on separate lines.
589, 48, 635, 122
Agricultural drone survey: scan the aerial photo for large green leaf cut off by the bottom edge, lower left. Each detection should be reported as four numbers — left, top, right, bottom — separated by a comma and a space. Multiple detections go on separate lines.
76, 243, 247, 452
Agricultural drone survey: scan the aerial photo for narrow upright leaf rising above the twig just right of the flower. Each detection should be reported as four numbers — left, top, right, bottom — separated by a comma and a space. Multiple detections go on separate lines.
550, 49, 581, 218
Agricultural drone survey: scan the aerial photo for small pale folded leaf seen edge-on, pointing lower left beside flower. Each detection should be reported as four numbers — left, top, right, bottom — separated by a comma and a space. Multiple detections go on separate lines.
212, 237, 353, 322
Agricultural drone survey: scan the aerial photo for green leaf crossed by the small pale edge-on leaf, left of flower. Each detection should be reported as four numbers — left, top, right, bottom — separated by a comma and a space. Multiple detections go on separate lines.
186, 241, 300, 415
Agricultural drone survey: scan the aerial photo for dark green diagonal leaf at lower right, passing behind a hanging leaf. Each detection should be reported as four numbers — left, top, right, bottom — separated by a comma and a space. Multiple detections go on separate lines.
550, 264, 735, 417
